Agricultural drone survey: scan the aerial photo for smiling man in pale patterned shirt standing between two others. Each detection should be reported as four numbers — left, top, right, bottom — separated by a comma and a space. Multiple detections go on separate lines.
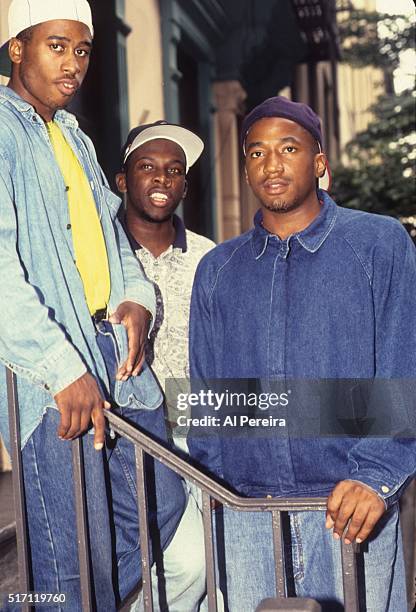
116, 121, 215, 612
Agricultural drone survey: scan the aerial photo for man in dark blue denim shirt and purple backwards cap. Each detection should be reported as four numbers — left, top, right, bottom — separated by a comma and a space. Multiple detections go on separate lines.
188, 97, 416, 612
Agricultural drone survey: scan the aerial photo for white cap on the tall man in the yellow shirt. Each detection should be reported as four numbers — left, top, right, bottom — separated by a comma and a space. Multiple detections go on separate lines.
0, 0, 94, 77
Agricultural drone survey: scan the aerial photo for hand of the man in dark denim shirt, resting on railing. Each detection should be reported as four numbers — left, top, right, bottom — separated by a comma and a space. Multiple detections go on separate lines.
325, 480, 386, 544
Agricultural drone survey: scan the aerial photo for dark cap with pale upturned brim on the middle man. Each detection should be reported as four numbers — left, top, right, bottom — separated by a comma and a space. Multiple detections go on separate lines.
122, 120, 204, 172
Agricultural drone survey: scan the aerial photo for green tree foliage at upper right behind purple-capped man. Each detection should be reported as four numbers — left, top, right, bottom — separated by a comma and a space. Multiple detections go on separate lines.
332, 9, 416, 224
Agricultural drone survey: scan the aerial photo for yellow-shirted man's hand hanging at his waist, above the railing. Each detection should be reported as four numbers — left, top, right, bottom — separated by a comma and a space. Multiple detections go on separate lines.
108, 302, 151, 380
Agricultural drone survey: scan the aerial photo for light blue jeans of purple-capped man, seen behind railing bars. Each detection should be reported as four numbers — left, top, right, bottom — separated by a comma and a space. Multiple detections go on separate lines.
215, 505, 407, 612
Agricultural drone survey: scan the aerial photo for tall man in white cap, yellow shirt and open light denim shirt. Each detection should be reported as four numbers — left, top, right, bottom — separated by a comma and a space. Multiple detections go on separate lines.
0, 0, 185, 612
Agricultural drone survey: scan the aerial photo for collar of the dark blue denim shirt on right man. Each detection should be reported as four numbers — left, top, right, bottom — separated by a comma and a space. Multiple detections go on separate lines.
252, 190, 338, 259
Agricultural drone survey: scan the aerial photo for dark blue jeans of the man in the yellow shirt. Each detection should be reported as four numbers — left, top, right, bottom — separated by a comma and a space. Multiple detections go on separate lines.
6, 322, 186, 612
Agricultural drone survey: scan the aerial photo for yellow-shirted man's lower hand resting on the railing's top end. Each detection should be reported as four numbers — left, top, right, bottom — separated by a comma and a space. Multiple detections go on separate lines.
54, 373, 111, 450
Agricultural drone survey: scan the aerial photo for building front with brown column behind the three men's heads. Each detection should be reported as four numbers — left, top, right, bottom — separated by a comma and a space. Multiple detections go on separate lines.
0, 0, 340, 241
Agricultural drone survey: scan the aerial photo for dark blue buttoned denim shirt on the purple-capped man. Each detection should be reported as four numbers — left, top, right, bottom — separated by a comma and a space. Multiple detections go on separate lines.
188, 192, 416, 505
